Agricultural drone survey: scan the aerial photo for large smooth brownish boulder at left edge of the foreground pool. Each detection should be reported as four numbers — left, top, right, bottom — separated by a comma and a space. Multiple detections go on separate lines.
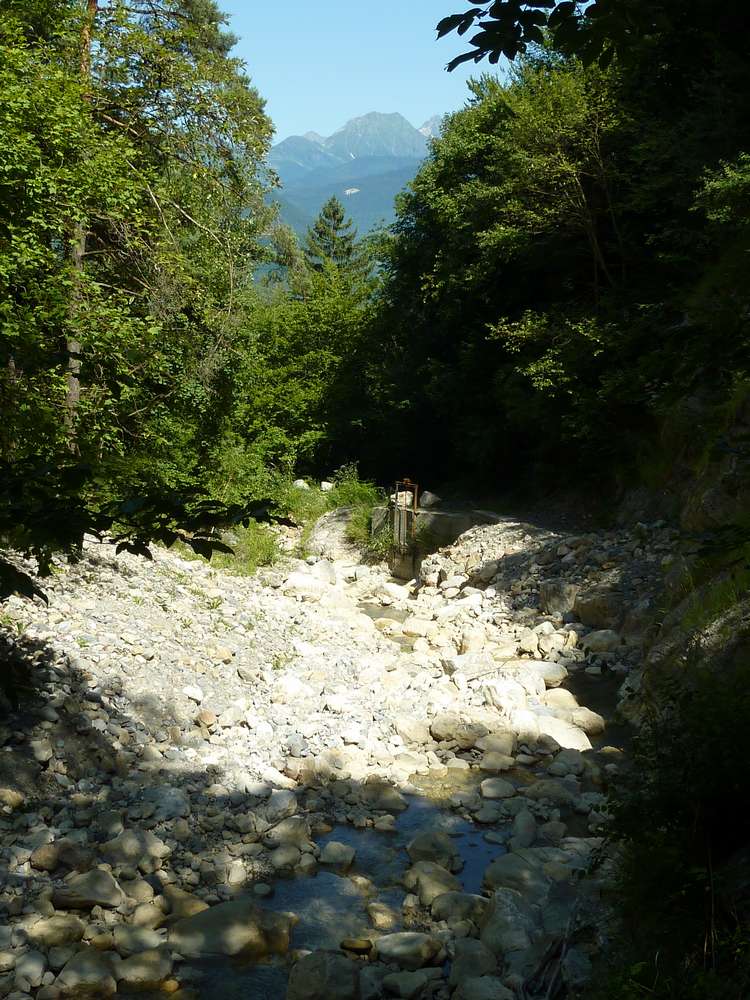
169, 899, 297, 958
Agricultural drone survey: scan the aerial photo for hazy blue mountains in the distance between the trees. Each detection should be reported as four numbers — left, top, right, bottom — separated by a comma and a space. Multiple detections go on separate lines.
268, 111, 441, 234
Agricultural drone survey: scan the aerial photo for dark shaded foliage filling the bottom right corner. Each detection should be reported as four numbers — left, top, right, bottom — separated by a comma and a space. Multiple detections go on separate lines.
591, 660, 750, 1000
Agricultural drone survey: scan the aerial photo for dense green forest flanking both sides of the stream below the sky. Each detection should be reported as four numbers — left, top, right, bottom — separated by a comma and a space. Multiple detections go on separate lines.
0, 0, 750, 1000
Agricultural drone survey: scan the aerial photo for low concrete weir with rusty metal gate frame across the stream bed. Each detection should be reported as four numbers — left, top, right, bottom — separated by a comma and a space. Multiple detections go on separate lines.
372, 503, 500, 580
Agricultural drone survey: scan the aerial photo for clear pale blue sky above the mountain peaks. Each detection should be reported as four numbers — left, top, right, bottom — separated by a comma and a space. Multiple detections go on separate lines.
218, 0, 490, 142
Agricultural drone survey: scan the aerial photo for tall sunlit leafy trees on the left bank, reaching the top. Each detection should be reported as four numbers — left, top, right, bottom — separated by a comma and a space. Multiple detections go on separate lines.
0, 0, 272, 492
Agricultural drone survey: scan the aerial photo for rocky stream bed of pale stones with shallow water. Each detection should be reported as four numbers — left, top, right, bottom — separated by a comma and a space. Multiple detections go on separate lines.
0, 508, 673, 1000
